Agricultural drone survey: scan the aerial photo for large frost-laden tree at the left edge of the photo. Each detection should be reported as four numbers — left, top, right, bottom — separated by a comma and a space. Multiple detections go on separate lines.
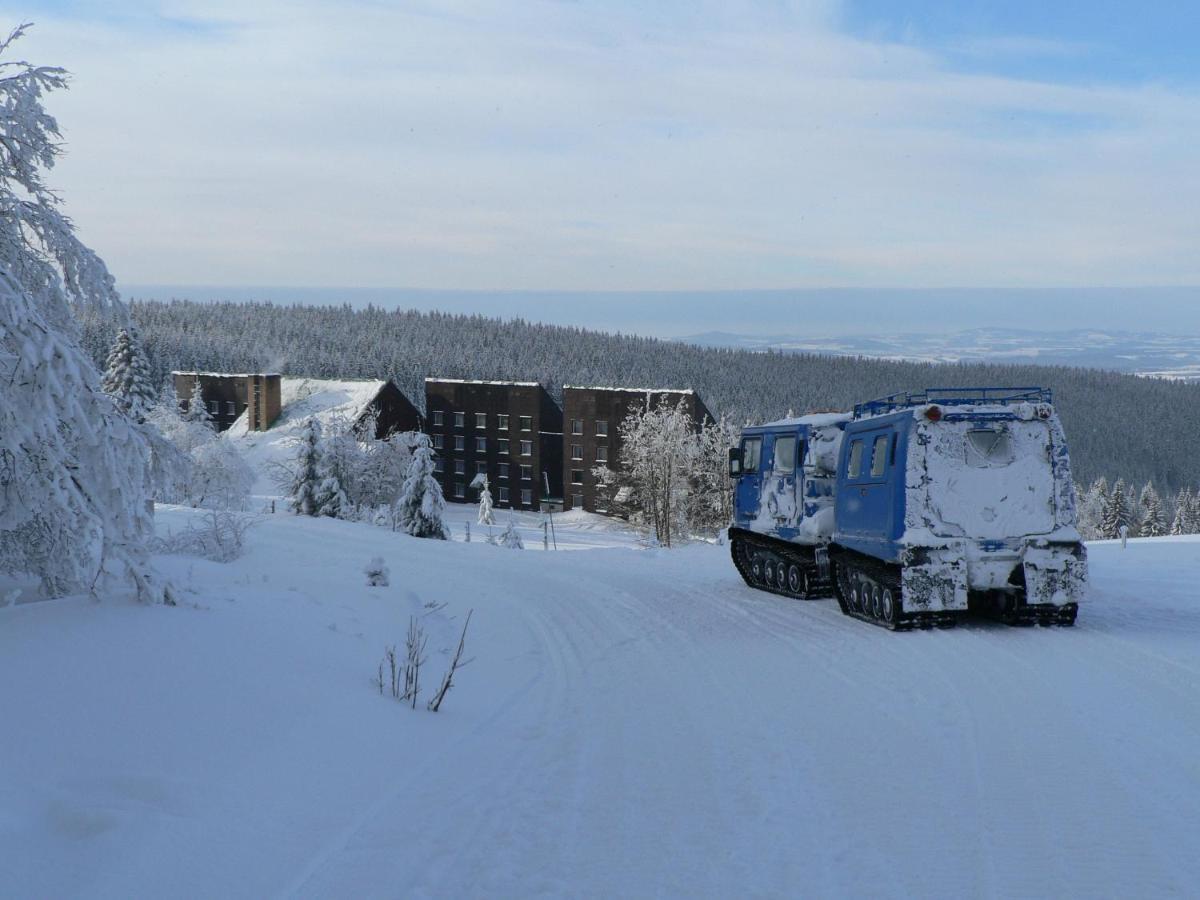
0, 25, 170, 601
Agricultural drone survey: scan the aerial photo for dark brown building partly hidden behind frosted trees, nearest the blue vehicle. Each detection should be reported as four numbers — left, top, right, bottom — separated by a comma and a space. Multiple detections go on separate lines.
563, 385, 712, 512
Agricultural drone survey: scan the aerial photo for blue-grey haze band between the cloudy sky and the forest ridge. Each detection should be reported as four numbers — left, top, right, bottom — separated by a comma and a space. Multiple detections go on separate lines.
120, 284, 1200, 337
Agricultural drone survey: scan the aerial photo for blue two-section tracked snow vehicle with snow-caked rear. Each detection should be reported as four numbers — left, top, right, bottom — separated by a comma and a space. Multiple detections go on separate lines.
730, 388, 1087, 629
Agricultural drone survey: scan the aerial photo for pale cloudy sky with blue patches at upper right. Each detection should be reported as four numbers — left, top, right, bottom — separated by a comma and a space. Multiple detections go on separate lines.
5, 0, 1200, 307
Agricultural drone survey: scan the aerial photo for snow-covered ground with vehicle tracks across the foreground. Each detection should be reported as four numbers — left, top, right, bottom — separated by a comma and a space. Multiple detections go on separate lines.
0, 508, 1200, 898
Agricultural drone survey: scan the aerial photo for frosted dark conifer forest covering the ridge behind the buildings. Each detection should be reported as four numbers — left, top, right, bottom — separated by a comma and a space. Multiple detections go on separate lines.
83, 300, 1200, 492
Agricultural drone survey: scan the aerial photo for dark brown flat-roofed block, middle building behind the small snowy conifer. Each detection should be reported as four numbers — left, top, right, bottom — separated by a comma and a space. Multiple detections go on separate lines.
425, 378, 563, 510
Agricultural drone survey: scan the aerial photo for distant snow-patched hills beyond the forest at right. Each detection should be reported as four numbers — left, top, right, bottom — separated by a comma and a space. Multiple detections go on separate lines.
677, 328, 1200, 382
